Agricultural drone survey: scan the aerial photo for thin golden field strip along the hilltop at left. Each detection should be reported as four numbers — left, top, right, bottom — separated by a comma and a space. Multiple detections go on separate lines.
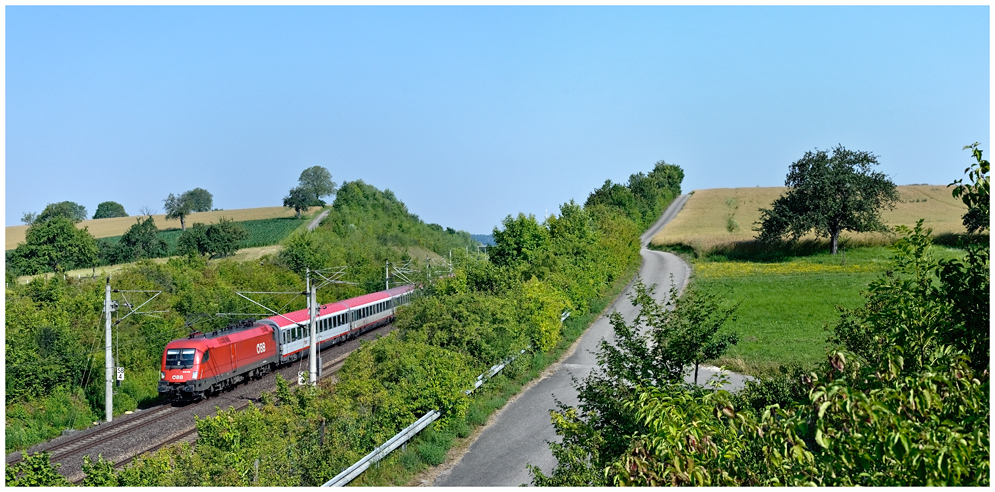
5, 207, 318, 249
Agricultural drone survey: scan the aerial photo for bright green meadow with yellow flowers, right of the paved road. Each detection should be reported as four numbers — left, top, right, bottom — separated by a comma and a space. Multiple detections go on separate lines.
680, 246, 962, 375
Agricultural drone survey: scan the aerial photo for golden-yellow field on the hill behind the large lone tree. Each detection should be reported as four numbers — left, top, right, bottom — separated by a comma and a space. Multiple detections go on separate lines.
651, 185, 967, 253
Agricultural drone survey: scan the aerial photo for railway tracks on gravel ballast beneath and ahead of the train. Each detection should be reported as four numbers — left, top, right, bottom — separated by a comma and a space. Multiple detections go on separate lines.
6, 325, 393, 484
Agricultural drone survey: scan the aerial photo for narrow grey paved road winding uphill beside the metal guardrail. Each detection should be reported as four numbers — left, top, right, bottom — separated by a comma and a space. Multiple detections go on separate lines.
433, 195, 756, 486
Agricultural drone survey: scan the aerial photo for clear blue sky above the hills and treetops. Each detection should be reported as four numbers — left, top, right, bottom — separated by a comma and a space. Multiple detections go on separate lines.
5, 6, 990, 233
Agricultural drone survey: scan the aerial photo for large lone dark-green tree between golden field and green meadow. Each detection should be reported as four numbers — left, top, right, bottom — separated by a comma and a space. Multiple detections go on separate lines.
754, 145, 898, 254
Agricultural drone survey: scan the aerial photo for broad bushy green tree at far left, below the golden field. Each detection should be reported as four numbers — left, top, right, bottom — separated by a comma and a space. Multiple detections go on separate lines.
7, 216, 97, 275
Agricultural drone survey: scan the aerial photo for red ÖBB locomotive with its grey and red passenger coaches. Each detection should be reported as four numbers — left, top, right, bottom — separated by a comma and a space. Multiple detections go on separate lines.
159, 285, 414, 401
